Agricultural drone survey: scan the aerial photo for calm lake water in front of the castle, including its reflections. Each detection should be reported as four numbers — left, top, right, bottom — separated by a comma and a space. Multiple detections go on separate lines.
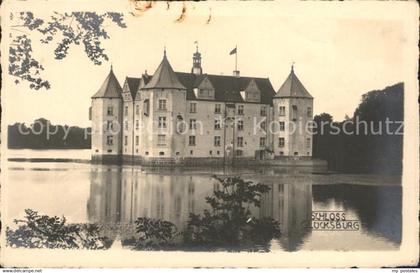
4, 150, 402, 251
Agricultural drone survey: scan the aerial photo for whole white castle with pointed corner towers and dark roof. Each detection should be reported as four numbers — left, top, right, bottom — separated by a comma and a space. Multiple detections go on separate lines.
91, 48, 313, 164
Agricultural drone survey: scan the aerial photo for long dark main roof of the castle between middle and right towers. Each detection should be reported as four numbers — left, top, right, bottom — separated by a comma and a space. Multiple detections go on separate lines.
175, 72, 276, 104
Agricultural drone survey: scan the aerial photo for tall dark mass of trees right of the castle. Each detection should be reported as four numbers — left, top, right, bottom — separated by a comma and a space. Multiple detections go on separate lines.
313, 83, 404, 174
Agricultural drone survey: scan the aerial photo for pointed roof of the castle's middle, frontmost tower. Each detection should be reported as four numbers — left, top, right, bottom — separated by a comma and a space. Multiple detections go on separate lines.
142, 52, 185, 89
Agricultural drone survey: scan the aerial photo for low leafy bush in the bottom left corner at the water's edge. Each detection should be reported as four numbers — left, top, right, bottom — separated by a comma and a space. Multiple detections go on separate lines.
6, 209, 110, 249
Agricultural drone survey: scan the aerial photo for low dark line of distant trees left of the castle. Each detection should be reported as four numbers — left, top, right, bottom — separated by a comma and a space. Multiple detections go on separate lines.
7, 118, 91, 149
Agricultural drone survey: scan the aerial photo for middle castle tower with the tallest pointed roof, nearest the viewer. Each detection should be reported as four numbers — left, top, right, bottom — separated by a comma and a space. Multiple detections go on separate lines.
134, 49, 186, 161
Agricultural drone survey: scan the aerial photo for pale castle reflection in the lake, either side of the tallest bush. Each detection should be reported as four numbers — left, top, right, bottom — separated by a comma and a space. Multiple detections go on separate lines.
87, 166, 312, 251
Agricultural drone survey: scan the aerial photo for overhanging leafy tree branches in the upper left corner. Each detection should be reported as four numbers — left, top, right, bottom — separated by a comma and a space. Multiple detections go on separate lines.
9, 12, 127, 90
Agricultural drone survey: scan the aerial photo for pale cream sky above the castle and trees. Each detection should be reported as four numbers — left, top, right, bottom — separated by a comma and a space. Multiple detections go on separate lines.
3, 1, 412, 126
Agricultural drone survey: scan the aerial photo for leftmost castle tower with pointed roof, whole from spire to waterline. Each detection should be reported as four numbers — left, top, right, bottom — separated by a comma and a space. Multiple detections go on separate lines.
91, 66, 123, 162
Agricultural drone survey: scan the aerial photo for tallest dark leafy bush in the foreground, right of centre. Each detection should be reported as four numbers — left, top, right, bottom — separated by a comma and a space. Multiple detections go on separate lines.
184, 176, 280, 248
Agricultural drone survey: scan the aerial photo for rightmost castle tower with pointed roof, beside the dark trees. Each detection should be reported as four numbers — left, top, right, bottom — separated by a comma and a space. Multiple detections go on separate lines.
273, 65, 313, 157
